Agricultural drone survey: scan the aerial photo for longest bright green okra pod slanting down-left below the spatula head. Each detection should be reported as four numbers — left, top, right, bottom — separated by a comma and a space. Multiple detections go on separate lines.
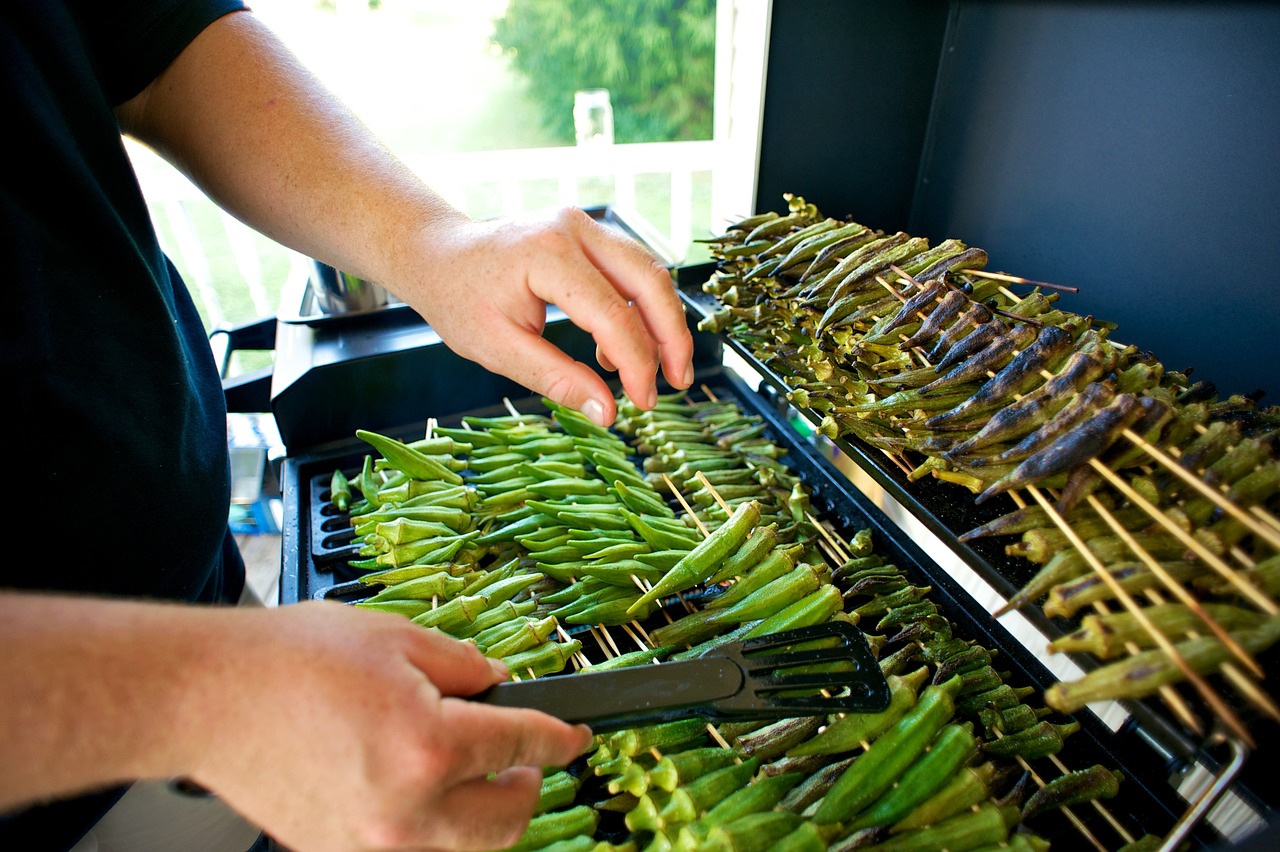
814, 678, 960, 823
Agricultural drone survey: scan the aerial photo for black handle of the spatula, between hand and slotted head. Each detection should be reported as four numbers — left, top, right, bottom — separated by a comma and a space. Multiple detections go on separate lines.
471, 656, 746, 733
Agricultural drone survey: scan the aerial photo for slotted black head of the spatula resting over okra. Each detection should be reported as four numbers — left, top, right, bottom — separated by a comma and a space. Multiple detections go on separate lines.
716, 622, 890, 715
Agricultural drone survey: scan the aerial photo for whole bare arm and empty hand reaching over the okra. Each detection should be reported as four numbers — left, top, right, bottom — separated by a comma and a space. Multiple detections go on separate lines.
118, 13, 692, 422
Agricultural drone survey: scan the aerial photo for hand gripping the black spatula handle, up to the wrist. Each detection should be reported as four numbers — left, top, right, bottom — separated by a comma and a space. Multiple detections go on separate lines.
183, 603, 590, 852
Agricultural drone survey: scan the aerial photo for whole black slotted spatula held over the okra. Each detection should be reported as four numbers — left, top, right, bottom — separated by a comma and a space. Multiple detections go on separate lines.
472, 622, 890, 733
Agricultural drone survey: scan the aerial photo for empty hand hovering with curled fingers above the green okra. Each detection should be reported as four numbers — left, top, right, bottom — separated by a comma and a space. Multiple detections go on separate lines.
399, 209, 694, 425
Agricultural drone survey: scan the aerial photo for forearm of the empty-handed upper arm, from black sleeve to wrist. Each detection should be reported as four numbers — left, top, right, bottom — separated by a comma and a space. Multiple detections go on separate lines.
118, 13, 455, 289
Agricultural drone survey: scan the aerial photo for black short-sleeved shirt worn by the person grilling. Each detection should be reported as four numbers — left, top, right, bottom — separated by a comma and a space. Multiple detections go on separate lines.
0, 0, 243, 848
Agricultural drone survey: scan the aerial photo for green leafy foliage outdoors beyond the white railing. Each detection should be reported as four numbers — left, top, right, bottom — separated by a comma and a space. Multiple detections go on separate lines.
493, 0, 716, 142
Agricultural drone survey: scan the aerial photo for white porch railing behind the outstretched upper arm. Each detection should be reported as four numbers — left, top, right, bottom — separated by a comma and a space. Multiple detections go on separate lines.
131, 141, 732, 327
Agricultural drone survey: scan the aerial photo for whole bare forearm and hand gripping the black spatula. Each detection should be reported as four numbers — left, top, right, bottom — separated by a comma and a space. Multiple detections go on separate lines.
0, 592, 589, 849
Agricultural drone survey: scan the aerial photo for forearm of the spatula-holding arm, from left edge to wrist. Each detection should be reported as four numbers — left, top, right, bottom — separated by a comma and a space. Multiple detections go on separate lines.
0, 592, 218, 809
